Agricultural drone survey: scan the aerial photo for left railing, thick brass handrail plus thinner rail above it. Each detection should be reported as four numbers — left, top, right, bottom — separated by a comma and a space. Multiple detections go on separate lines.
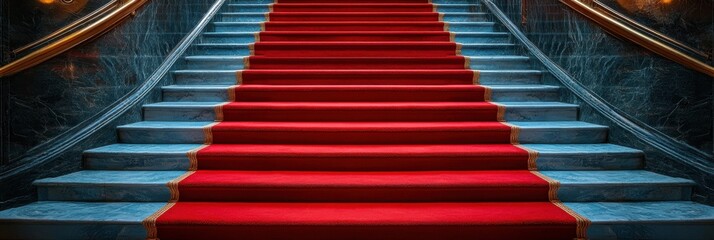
0, 0, 148, 77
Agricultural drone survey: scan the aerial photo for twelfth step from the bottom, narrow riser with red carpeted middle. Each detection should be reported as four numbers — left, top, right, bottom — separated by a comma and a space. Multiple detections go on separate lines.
217, 13, 491, 22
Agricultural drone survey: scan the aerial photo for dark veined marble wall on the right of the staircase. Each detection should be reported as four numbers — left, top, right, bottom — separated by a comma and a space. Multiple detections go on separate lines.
494, 0, 714, 203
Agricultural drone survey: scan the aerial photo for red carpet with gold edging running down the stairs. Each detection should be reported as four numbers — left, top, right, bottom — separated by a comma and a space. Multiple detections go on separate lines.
149, 0, 584, 240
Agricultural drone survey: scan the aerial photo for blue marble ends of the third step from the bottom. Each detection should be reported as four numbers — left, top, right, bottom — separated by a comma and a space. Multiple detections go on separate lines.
84, 144, 643, 171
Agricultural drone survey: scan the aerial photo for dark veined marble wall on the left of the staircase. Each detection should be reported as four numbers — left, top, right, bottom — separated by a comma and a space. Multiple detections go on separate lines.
0, 0, 215, 208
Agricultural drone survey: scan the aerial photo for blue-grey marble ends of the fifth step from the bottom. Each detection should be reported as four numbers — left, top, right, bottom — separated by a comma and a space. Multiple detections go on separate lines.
143, 102, 578, 121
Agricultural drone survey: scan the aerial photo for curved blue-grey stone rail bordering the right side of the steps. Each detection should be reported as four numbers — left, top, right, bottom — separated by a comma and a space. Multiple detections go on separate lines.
480, 0, 714, 175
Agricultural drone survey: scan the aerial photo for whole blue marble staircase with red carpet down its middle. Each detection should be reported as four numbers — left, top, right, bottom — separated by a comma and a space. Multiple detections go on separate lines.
0, 0, 714, 239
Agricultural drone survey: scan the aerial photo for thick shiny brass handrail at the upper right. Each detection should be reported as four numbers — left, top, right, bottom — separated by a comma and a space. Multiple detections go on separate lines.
560, 0, 714, 77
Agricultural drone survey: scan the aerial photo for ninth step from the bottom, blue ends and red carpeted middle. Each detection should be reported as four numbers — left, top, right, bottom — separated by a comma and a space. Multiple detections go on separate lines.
189, 42, 520, 57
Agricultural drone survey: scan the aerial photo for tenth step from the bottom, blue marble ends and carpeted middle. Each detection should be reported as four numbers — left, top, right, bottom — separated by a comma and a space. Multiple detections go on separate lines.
201, 31, 511, 44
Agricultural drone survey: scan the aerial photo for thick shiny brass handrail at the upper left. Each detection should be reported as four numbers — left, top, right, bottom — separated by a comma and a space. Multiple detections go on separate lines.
0, 0, 148, 77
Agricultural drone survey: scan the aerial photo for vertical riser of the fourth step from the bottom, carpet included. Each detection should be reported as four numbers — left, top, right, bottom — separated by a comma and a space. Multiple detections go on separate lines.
119, 127, 607, 144
